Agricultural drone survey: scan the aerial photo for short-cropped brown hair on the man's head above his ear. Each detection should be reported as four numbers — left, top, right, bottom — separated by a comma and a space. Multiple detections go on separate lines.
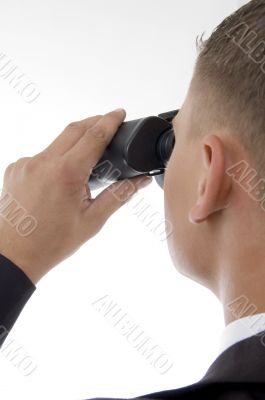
191, 0, 265, 177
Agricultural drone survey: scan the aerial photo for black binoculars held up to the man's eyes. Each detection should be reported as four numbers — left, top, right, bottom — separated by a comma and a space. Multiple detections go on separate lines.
88, 110, 179, 191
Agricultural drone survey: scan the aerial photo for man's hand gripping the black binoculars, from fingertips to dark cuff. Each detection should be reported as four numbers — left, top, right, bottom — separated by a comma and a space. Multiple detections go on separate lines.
0, 110, 152, 283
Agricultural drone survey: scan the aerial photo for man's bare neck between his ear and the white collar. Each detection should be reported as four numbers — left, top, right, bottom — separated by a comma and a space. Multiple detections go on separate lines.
206, 203, 265, 325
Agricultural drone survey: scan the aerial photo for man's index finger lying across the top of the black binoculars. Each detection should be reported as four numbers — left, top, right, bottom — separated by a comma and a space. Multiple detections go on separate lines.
65, 109, 126, 176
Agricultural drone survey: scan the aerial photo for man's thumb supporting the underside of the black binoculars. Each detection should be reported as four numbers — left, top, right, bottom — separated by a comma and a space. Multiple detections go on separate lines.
89, 175, 153, 223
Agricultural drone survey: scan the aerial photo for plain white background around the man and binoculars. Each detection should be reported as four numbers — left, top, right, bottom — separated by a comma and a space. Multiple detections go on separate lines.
0, 0, 248, 400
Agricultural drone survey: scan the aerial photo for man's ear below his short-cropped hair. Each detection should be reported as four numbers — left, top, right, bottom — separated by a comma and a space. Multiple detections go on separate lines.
189, 135, 232, 224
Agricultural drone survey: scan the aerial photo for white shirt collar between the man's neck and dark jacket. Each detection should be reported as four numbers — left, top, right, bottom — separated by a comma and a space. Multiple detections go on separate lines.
219, 313, 265, 355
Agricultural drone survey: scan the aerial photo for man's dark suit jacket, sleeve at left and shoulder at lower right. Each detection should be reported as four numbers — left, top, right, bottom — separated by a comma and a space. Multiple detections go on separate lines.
0, 255, 265, 400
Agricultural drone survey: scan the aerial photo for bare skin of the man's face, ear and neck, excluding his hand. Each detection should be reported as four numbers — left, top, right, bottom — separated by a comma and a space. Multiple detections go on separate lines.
164, 86, 265, 324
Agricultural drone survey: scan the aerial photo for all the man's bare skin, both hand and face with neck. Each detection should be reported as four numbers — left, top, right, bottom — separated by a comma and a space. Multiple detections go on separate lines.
0, 95, 265, 324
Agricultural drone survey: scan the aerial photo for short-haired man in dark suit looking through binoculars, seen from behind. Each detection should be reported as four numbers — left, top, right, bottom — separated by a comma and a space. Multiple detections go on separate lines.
0, 0, 265, 400
